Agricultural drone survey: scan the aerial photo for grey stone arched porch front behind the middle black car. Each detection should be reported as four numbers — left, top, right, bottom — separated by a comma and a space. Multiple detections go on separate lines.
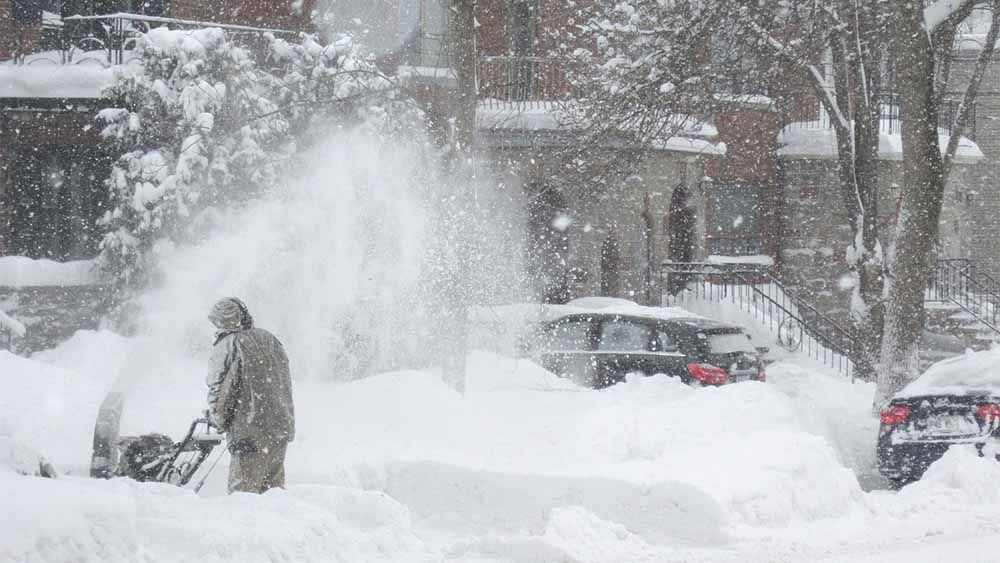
481, 138, 720, 303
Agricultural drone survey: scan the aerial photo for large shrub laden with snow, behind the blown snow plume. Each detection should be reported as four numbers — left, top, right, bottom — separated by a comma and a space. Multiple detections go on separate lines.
98, 27, 400, 286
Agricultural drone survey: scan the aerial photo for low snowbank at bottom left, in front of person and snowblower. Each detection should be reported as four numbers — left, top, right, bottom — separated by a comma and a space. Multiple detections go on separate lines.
0, 472, 431, 563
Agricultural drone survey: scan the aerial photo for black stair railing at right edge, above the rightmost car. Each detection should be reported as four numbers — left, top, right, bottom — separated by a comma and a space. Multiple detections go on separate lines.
926, 258, 1000, 334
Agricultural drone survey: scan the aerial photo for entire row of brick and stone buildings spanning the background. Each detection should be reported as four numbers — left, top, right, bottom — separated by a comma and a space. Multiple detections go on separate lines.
0, 0, 1000, 328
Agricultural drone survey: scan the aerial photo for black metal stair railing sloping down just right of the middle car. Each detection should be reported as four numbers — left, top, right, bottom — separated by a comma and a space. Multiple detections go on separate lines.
660, 262, 861, 379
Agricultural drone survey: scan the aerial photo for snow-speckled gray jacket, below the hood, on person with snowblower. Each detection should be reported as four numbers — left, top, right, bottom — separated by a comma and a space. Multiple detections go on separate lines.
207, 328, 295, 448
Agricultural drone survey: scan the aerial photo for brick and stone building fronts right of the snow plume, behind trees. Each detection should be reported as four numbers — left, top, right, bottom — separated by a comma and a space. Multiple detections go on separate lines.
458, 0, 1000, 319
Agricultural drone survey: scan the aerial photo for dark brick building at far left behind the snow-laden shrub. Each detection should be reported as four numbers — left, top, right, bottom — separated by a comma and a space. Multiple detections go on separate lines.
0, 0, 313, 260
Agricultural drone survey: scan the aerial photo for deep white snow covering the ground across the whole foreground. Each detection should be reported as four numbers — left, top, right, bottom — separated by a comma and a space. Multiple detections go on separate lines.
0, 333, 1000, 561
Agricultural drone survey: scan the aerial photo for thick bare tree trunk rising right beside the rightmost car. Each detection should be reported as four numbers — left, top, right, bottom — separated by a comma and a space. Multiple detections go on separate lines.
875, 0, 944, 408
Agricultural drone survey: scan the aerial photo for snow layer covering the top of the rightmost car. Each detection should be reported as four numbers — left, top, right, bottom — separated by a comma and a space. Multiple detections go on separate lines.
896, 349, 1000, 398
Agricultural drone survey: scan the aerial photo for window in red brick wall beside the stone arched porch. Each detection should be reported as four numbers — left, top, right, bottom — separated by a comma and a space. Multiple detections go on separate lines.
705, 184, 763, 256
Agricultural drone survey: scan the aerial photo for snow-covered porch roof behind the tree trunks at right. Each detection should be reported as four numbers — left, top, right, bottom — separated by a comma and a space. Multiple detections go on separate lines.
778, 120, 986, 164
